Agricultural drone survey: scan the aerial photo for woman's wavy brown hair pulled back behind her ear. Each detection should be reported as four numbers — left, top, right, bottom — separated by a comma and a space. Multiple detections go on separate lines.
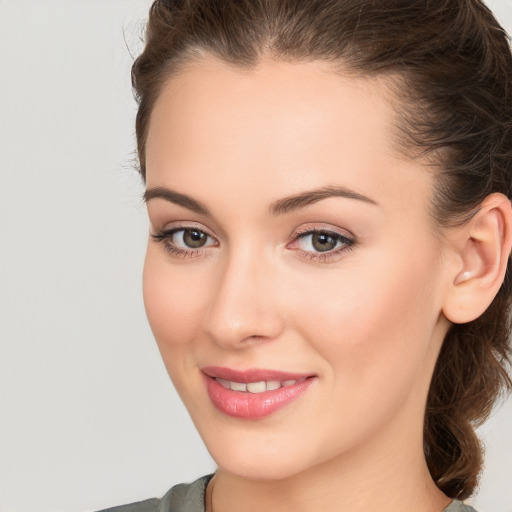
132, 0, 512, 499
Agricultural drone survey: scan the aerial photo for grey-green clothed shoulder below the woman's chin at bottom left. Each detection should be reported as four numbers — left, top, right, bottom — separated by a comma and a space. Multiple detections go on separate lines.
98, 475, 213, 512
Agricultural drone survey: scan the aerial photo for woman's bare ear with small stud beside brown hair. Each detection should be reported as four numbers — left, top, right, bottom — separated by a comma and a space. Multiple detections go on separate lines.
443, 193, 512, 324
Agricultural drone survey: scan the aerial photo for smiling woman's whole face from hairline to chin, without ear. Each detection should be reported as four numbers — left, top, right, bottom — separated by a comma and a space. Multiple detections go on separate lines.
144, 59, 449, 479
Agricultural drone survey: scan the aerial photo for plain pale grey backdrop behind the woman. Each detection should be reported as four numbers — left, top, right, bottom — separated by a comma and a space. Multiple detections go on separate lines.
0, 0, 512, 512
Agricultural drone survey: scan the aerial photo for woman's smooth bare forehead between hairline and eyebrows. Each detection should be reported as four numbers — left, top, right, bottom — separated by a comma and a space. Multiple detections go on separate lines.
146, 59, 434, 220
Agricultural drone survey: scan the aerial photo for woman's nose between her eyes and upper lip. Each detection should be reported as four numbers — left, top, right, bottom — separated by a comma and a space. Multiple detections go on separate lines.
204, 244, 283, 348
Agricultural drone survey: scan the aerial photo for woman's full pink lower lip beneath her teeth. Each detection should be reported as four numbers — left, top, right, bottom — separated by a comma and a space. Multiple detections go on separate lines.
205, 375, 317, 419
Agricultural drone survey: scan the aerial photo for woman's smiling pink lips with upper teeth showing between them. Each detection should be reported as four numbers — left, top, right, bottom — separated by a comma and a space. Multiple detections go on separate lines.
202, 367, 317, 419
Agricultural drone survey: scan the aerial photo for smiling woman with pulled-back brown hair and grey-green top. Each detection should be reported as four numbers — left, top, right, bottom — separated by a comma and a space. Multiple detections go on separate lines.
101, 0, 512, 512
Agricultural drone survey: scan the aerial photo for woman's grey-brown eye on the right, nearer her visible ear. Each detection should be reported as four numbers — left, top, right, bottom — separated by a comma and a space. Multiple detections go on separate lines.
288, 229, 355, 261
